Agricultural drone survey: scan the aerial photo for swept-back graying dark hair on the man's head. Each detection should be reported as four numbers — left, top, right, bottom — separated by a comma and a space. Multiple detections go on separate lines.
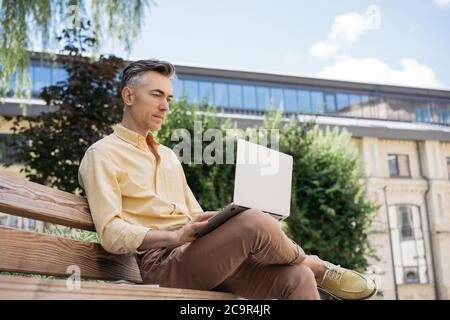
120, 59, 175, 91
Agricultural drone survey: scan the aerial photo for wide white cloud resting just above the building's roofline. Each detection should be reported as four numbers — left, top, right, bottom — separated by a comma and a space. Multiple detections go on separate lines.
315, 58, 444, 89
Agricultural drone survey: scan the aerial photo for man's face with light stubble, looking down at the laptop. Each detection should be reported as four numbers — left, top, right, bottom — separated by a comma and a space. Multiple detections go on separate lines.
122, 71, 173, 130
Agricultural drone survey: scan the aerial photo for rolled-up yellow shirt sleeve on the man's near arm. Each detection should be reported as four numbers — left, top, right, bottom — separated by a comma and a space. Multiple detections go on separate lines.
78, 148, 150, 254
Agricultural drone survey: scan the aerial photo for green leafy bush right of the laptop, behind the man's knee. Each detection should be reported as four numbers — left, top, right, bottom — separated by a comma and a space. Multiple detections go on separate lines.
281, 121, 377, 271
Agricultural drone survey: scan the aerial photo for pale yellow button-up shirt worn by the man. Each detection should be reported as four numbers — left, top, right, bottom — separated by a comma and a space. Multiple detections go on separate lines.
78, 124, 203, 254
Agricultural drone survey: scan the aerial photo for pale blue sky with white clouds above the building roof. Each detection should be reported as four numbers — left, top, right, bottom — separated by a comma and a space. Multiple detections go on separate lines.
102, 0, 450, 90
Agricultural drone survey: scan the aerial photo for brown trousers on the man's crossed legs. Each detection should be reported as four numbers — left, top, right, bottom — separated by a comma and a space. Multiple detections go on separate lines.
137, 209, 319, 299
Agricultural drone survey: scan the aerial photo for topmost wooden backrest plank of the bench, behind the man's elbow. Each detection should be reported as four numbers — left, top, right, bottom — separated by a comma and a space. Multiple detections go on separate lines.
0, 173, 95, 231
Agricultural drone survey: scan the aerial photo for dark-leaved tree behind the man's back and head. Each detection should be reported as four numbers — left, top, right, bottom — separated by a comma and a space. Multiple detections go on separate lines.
5, 22, 124, 192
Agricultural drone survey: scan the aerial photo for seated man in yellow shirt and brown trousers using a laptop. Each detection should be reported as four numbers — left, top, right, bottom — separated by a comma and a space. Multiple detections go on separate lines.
79, 60, 376, 299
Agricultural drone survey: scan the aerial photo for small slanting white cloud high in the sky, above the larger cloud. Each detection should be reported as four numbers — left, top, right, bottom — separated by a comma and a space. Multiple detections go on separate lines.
309, 6, 381, 59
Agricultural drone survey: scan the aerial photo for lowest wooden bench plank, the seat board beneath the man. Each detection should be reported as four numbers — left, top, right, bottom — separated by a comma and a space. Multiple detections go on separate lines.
0, 276, 239, 300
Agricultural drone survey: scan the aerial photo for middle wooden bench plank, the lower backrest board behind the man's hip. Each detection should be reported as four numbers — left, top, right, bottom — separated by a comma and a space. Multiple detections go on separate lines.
0, 226, 142, 283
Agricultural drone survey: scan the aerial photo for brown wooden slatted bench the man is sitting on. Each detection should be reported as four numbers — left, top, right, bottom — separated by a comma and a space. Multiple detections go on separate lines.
0, 174, 238, 300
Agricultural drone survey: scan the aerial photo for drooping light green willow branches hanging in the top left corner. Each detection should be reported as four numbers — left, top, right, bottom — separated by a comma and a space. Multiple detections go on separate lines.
0, 0, 149, 98
